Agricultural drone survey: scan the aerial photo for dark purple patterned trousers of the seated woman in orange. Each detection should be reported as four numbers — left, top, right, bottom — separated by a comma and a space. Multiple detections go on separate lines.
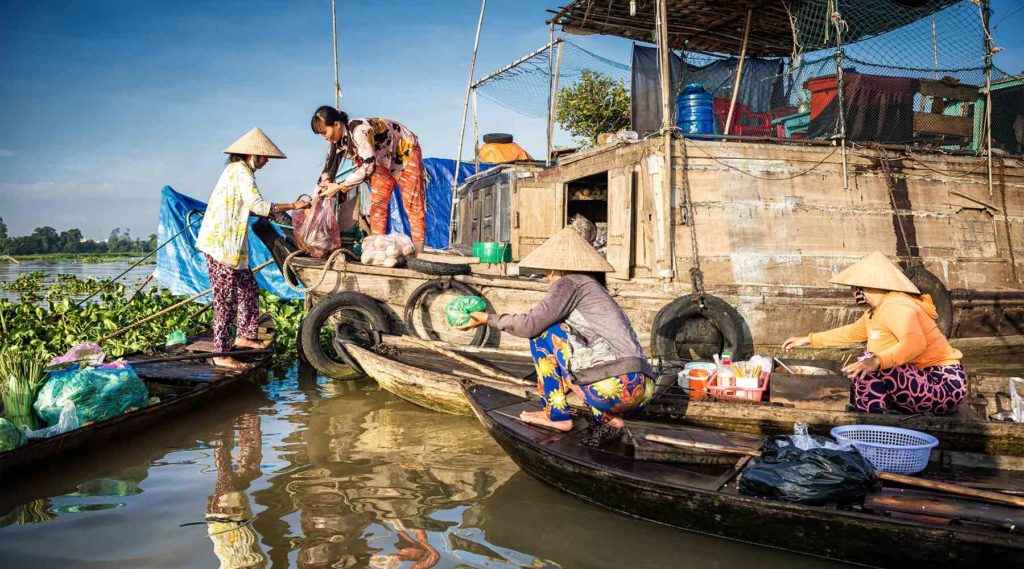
853, 363, 967, 414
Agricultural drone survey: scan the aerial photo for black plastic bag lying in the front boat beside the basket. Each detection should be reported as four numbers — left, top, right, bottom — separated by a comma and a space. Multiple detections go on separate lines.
739, 435, 880, 506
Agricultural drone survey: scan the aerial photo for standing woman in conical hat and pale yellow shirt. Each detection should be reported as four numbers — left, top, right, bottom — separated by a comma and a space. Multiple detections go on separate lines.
196, 128, 309, 367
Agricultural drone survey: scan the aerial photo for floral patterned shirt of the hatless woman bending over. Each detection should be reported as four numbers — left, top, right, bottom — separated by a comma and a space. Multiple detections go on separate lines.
338, 119, 420, 187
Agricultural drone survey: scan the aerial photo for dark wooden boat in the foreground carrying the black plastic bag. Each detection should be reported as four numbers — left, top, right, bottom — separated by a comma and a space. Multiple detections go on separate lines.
465, 383, 1024, 568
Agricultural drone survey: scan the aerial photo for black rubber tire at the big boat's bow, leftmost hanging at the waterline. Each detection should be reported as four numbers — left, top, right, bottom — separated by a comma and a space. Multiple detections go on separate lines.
299, 291, 388, 380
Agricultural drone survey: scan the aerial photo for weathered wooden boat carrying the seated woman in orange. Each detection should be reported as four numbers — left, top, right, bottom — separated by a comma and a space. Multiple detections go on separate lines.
347, 337, 1024, 460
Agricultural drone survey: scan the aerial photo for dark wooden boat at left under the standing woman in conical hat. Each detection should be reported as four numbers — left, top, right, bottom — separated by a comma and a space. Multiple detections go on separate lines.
0, 321, 273, 485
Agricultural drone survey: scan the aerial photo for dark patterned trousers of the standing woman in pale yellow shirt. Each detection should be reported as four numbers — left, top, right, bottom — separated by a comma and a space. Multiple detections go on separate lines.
206, 255, 259, 352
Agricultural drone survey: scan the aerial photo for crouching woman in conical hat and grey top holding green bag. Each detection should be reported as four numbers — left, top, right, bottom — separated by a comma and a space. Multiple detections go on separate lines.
462, 227, 654, 443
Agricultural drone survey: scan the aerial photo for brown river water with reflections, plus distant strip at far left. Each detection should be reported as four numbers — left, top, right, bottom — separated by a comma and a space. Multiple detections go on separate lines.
0, 263, 1007, 569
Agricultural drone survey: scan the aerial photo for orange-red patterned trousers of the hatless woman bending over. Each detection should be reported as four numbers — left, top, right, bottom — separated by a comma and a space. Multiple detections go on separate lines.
370, 144, 427, 244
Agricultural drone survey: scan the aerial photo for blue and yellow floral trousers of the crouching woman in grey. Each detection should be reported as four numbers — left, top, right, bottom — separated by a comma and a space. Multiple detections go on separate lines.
529, 322, 654, 423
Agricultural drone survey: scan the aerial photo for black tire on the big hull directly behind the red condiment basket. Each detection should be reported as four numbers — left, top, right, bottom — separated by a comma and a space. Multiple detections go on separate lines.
650, 295, 745, 361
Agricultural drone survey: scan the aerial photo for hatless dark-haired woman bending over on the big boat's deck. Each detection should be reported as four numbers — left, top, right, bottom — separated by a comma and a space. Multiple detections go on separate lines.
310, 105, 426, 253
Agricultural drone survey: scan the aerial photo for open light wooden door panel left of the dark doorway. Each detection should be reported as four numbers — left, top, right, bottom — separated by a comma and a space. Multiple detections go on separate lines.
511, 179, 565, 261
